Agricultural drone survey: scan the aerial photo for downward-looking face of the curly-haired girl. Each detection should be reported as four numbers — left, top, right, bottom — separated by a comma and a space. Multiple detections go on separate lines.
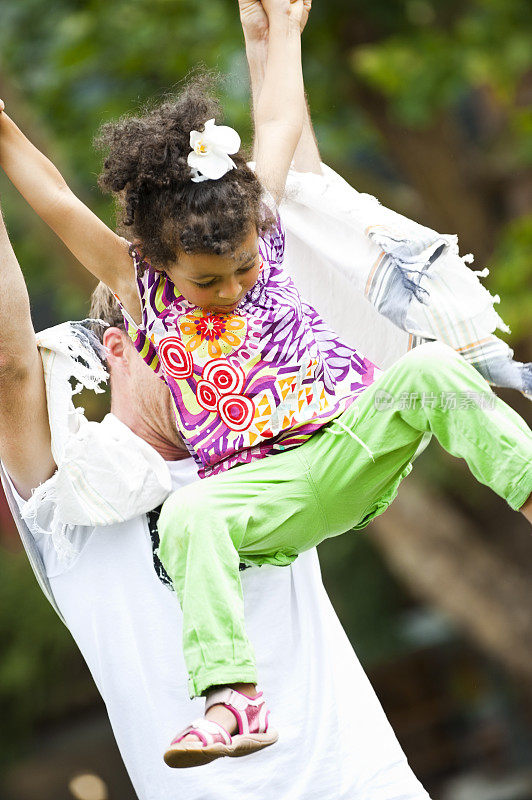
165, 228, 262, 314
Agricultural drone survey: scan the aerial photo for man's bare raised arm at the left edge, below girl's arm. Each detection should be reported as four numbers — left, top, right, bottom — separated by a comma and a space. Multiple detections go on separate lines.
0, 202, 55, 499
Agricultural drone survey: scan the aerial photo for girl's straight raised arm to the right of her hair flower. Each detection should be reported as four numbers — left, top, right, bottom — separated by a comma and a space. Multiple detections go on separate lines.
255, 0, 305, 203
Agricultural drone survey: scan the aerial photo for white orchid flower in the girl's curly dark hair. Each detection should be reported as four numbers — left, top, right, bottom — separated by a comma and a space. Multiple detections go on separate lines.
187, 119, 240, 183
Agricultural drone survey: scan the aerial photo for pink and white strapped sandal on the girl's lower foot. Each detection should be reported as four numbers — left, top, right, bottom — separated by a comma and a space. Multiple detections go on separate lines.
164, 688, 278, 768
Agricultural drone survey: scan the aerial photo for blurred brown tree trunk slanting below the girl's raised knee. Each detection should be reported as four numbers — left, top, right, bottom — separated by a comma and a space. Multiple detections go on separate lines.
371, 477, 532, 694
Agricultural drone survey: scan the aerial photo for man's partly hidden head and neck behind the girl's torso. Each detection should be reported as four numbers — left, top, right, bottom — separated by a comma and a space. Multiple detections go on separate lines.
90, 283, 189, 461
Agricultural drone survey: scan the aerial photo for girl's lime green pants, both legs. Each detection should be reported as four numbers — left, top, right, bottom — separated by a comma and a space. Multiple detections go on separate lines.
159, 342, 532, 697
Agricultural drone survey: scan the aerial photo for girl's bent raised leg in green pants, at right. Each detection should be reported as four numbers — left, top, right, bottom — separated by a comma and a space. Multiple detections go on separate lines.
301, 342, 532, 536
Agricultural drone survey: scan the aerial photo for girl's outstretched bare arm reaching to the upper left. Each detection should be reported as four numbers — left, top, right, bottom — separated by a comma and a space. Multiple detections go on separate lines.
0, 101, 140, 318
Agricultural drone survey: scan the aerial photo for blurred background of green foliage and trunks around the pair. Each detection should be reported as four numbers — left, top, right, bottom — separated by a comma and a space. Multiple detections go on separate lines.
0, 0, 532, 800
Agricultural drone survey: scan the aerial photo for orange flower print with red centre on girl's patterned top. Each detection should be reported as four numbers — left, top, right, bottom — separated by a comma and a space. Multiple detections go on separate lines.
179, 308, 247, 358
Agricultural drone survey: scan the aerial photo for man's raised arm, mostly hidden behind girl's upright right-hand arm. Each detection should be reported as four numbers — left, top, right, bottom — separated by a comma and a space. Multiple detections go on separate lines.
239, 0, 322, 175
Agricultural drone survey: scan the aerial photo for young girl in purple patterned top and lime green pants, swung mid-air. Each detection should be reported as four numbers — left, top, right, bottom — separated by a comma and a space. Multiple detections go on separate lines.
0, 0, 532, 767
